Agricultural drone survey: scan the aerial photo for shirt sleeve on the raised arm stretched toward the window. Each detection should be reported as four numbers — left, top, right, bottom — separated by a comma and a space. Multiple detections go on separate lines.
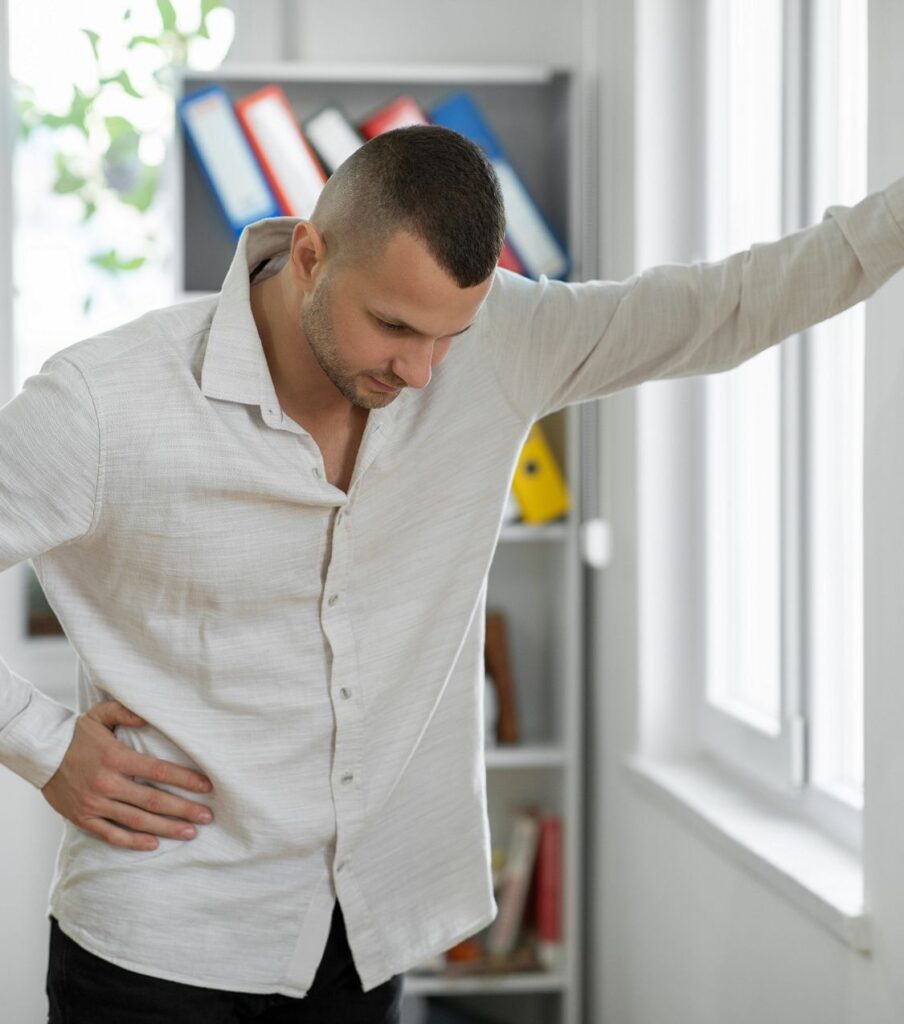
489, 178, 904, 420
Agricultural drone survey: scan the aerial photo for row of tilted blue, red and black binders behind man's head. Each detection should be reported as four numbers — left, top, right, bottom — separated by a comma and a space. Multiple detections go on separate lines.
178, 84, 570, 279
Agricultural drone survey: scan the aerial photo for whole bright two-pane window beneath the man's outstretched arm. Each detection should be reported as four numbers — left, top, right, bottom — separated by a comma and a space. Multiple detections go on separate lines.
701, 0, 866, 845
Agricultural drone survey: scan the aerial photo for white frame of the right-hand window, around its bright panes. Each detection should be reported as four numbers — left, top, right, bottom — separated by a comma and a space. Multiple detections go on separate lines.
697, 0, 862, 855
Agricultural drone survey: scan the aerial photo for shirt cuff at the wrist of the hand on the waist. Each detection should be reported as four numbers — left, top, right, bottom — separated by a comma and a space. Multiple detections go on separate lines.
0, 673, 78, 790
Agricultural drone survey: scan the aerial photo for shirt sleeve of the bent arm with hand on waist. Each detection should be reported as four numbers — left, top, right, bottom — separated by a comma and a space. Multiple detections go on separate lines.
0, 355, 100, 788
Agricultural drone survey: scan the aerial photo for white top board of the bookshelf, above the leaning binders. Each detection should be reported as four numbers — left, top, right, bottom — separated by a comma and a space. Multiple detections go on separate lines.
176, 61, 567, 85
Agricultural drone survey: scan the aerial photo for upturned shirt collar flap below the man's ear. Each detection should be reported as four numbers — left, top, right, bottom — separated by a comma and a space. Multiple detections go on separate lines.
201, 217, 300, 409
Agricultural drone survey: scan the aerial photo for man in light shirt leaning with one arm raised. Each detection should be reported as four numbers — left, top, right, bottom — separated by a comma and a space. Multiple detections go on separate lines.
0, 121, 904, 1024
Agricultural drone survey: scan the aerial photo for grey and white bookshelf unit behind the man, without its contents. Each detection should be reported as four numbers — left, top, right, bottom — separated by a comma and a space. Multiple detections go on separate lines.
173, 62, 595, 1024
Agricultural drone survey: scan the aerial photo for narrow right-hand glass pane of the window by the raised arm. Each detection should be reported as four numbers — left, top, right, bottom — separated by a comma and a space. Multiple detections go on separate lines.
806, 0, 867, 808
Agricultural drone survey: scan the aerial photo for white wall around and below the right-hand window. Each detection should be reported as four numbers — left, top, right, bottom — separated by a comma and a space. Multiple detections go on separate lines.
588, 6, 904, 1024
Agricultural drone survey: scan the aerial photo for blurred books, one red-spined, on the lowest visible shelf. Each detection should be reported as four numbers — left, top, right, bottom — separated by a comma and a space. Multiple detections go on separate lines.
412, 805, 562, 978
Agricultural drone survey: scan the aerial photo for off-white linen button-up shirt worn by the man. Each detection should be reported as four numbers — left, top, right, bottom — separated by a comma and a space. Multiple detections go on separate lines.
0, 179, 904, 996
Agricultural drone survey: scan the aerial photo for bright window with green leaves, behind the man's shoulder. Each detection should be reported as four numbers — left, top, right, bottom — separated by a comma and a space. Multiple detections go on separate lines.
7, 0, 233, 638
